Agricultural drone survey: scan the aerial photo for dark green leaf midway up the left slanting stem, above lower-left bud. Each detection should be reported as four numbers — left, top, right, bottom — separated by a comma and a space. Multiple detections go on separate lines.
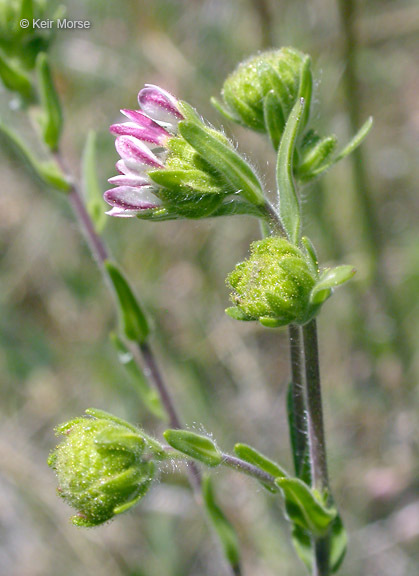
105, 260, 150, 344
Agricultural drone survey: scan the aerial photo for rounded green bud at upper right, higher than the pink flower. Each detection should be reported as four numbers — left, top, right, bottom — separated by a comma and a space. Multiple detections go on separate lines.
213, 48, 312, 148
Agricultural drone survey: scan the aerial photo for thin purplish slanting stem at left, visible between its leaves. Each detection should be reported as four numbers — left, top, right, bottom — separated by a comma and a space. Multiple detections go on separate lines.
55, 153, 241, 576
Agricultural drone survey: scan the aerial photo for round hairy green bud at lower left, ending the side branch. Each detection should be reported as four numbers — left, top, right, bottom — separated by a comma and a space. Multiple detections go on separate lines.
48, 410, 155, 527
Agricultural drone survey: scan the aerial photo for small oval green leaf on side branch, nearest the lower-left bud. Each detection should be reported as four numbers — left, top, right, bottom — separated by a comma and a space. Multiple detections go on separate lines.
163, 429, 223, 466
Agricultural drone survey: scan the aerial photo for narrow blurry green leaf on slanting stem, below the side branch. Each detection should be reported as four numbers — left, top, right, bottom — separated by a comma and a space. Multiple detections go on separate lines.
202, 476, 241, 574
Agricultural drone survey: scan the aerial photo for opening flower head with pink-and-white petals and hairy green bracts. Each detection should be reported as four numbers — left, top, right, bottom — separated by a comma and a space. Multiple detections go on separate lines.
104, 84, 264, 220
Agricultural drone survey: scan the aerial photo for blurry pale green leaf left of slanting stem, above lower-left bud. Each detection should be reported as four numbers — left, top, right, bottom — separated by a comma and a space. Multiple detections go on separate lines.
110, 333, 167, 420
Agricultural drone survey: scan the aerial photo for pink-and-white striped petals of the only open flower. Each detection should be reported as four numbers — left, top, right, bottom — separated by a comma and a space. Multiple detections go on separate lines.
104, 84, 183, 217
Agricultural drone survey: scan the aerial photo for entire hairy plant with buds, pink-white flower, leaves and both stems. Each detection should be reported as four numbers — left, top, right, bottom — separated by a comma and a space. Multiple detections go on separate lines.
0, 2, 371, 576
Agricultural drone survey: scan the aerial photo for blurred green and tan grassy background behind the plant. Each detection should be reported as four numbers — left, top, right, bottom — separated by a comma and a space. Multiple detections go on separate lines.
0, 0, 419, 576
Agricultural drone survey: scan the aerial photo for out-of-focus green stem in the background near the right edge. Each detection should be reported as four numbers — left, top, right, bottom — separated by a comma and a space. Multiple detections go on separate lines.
338, 0, 413, 371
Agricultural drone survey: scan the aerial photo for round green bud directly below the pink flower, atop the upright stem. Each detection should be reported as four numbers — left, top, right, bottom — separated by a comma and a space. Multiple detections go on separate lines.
226, 237, 319, 327
